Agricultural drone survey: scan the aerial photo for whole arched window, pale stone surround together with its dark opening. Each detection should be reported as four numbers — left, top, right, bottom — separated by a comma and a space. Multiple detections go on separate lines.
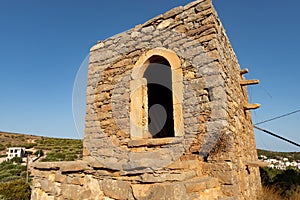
130, 48, 184, 140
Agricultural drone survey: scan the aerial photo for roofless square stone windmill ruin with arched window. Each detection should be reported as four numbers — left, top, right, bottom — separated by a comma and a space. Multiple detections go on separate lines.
32, 0, 261, 200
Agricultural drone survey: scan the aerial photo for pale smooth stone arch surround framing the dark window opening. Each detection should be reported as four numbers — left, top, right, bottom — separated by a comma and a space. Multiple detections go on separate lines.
130, 48, 184, 139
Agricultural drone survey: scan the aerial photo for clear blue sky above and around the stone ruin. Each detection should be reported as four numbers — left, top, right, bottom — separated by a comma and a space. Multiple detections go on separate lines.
0, 0, 300, 151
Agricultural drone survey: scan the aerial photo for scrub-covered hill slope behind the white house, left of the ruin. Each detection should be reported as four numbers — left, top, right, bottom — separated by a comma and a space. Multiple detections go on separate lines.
0, 131, 82, 162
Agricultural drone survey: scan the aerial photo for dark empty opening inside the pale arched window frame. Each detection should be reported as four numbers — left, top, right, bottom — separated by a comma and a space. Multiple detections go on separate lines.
144, 56, 175, 138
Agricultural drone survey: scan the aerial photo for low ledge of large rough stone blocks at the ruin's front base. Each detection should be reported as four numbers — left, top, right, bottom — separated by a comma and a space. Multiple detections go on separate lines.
32, 160, 221, 200
